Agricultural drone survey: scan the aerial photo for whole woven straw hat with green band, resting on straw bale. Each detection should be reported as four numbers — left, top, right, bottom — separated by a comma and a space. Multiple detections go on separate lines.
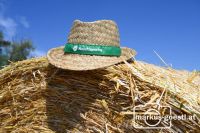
47, 20, 136, 71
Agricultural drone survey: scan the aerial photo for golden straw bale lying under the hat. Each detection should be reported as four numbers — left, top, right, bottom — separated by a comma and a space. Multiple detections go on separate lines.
0, 58, 200, 133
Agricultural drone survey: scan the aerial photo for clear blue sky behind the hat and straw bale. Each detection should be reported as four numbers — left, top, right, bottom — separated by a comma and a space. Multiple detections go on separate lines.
0, 0, 200, 70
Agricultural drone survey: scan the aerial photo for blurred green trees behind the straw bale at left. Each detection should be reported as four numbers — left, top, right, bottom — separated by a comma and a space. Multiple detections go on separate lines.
0, 31, 35, 69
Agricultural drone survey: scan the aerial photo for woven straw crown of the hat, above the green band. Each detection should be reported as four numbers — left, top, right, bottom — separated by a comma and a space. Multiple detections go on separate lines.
68, 20, 120, 46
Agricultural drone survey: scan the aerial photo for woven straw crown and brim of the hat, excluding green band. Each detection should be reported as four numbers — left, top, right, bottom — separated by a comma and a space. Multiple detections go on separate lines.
47, 20, 136, 71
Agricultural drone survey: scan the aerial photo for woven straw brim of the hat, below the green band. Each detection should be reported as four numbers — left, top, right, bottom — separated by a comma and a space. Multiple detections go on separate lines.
47, 46, 136, 71
